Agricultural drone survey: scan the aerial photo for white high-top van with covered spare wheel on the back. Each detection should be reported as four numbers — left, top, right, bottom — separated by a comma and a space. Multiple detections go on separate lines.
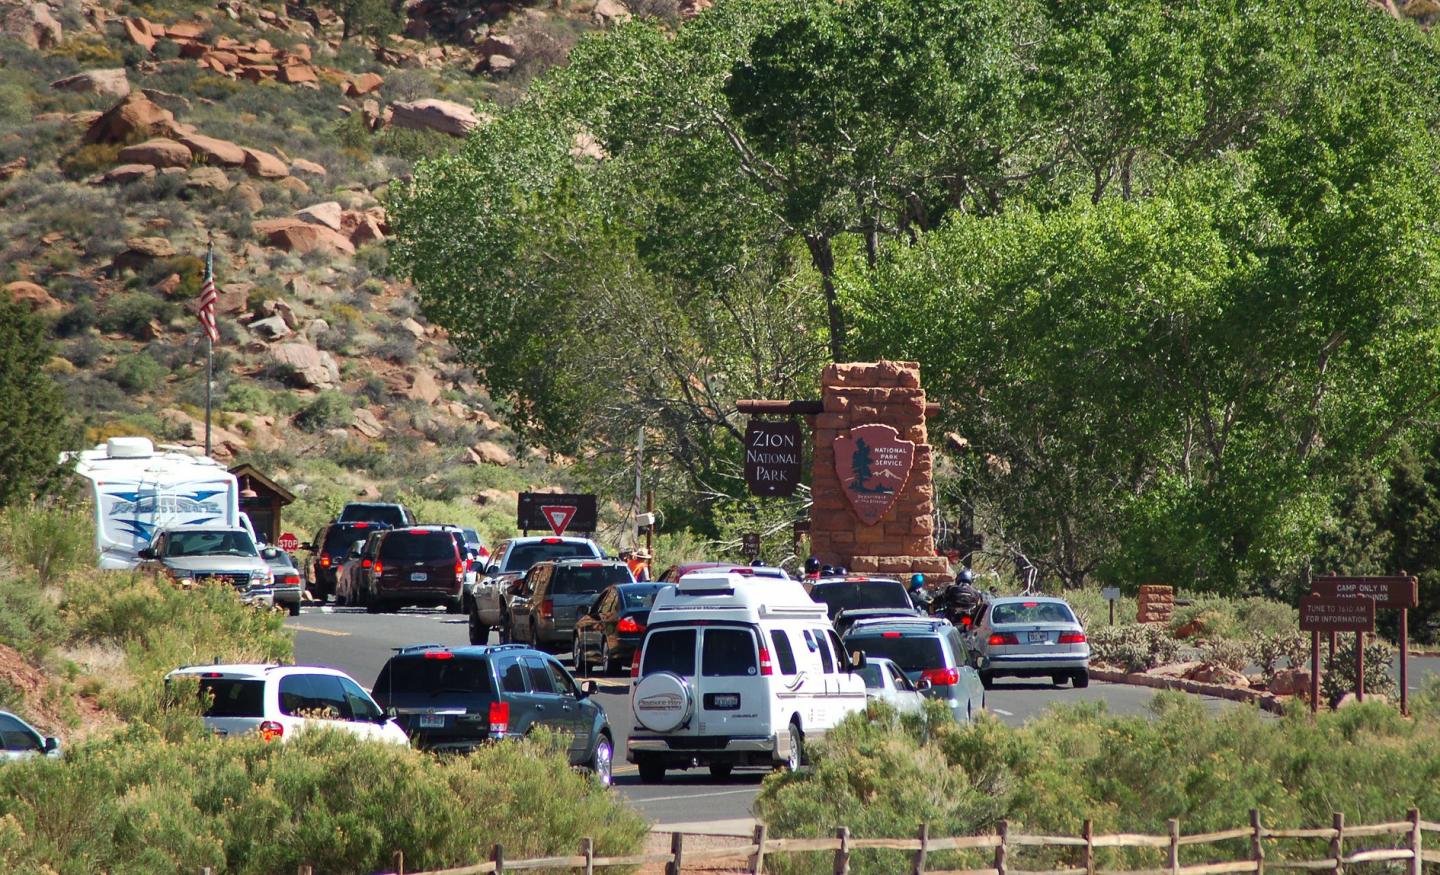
626, 568, 865, 783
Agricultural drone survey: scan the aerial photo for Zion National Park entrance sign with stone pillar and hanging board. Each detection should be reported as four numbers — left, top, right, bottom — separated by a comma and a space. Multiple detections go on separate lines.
737, 361, 952, 583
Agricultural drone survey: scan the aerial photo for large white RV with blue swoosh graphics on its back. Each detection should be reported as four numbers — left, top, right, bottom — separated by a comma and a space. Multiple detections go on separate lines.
68, 438, 253, 568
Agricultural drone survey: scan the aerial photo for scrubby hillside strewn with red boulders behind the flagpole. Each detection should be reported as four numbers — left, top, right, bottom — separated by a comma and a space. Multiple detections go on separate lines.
0, 0, 691, 532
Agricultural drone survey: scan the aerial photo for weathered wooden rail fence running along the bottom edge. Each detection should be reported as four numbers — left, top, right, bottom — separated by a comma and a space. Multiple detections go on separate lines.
262, 809, 1440, 875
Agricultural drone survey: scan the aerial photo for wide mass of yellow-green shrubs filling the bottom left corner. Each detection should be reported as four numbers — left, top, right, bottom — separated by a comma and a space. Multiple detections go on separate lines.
0, 728, 648, 875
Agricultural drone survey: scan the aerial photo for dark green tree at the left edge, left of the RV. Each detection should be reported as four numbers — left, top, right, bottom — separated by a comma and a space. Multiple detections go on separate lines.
0, 298, 68, 507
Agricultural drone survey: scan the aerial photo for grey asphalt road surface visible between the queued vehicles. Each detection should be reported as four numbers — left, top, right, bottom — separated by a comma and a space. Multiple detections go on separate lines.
287, 607, 1440, 833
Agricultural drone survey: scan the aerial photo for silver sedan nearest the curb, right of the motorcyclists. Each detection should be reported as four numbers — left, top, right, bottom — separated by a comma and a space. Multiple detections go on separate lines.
968, 596, 1090, 689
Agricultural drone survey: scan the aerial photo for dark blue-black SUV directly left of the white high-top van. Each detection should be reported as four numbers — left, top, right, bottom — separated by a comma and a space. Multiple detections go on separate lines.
374, 645, 615, 787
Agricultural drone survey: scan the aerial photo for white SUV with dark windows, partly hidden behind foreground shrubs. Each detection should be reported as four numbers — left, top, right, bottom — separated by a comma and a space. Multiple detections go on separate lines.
166, 665, 409, 744
